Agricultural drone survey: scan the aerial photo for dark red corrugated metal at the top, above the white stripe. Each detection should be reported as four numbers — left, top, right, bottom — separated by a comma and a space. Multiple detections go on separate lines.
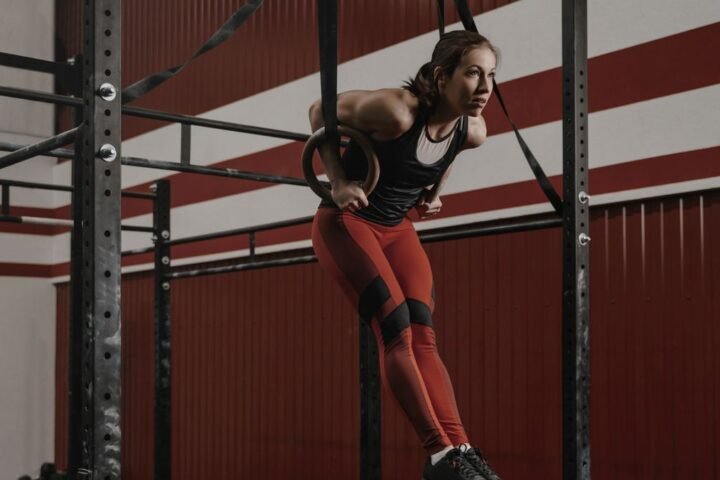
56, 0, 511, 138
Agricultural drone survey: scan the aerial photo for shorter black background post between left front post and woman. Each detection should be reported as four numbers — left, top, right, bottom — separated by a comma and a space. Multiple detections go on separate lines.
153, 180, 172, 480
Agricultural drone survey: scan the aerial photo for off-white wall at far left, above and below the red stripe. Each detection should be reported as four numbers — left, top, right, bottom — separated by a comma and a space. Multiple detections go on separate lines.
0, 0, 55, 478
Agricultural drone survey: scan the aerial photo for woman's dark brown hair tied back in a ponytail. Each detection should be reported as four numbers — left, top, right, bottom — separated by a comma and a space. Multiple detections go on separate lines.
402, 30, 498, 108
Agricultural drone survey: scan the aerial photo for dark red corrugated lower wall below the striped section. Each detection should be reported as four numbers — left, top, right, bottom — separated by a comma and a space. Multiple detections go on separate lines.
56, 192, 720, 480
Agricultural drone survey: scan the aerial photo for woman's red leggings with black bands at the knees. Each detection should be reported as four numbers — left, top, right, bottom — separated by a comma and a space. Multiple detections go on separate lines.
312, 207, 468, 454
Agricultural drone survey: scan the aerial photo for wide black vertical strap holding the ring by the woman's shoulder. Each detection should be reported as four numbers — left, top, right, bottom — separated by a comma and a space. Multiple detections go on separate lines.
318, 0, 340, 149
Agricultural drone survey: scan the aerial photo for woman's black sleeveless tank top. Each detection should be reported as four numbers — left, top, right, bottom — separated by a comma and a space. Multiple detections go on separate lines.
321, 110, 468, 226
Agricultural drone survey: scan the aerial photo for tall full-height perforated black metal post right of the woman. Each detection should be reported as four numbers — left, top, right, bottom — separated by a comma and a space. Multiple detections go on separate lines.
562, 0, 590, 480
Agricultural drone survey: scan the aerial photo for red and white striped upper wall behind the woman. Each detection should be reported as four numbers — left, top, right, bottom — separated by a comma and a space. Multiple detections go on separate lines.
0, 0, 720, 280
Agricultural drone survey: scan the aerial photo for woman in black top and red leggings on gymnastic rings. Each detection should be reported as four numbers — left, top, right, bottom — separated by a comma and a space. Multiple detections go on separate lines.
309, 31, 499, 480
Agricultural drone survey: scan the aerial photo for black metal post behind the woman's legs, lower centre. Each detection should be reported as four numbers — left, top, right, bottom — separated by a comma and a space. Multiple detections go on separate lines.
360, 319, 382, 480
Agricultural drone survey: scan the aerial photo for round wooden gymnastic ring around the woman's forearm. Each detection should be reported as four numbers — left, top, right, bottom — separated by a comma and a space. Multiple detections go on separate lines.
302, 125, 380, 202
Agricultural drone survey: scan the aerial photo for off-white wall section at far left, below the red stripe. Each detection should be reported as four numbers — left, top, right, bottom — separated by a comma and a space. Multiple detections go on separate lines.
0, 277, 55, 478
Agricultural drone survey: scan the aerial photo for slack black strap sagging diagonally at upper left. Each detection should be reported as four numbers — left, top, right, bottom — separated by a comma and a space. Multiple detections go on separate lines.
122, 0, 263, 103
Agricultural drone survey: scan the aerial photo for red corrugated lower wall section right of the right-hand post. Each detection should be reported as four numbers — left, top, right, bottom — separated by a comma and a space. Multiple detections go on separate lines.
592, 193, 720, 479
